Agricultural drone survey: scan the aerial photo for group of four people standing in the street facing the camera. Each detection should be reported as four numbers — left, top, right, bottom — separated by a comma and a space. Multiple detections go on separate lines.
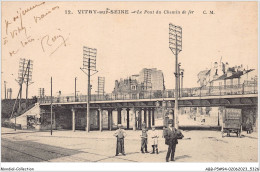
114, 124, 184, 162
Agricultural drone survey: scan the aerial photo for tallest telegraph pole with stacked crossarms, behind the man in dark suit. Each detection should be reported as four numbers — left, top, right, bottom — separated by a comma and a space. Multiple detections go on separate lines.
169, 23, 182, 129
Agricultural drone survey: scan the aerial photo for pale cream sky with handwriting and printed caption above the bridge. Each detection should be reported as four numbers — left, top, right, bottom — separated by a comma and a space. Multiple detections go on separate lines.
1, 2, 258, 98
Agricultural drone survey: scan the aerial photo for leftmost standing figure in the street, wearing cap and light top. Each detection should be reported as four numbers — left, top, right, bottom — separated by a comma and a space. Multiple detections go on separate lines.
114, 124, 126, 156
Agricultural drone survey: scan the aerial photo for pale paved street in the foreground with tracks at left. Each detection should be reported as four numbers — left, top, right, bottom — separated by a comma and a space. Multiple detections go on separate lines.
1, 128, 258, 162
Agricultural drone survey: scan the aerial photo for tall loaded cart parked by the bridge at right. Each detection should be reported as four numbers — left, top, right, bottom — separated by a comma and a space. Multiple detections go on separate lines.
222, 108, 242, 137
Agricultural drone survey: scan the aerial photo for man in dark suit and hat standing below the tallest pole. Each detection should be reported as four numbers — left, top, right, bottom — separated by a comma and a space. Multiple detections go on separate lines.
164, 124, 178, 162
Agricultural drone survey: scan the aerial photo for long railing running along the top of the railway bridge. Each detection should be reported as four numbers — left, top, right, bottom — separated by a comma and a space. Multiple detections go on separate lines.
38, 83, 258, 103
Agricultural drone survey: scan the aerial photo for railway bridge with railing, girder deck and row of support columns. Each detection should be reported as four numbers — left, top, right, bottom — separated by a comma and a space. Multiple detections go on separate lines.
38, 85, 258, 131
